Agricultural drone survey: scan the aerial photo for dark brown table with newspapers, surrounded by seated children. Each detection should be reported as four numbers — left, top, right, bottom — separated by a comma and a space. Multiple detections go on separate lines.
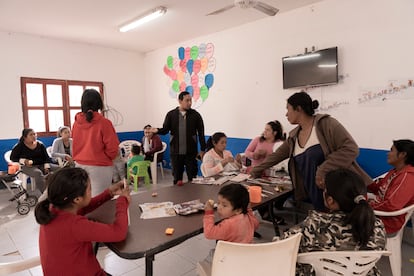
88, 179, 292, 275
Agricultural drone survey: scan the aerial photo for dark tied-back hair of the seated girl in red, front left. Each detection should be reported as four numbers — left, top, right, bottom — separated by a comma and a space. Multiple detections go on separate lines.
35, 168, 89, 224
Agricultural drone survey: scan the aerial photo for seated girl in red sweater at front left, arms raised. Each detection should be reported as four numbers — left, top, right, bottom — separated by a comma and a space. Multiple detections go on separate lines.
35, 168, 130, 276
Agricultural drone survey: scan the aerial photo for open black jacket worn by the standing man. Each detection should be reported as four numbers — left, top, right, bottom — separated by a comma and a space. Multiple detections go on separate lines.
158, 107, 206, 156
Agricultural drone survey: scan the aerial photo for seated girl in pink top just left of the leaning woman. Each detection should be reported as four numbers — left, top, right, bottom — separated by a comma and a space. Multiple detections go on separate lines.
244, 121, 286, 167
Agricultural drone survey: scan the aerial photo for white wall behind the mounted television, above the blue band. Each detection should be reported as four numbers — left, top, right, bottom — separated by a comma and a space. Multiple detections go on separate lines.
145, 0, 414, 149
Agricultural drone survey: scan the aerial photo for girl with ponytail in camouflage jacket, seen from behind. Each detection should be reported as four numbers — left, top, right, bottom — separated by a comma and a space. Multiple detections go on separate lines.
284, 169, 385, 275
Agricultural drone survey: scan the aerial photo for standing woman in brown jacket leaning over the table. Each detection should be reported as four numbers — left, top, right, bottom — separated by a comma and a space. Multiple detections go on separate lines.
251, 91, 372, 210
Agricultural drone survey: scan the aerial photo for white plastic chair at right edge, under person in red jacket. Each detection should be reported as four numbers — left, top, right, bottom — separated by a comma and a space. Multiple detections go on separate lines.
374, 204, 414, 276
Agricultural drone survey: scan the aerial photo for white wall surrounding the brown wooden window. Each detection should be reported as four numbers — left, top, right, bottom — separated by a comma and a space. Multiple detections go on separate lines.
0, 32, 146, 139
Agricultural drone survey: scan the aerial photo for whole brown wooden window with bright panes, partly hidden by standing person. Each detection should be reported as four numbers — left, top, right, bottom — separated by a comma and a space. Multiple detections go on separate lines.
21, 77, 103, 136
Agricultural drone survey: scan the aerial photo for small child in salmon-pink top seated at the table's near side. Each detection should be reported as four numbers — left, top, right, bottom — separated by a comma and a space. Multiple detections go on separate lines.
203, 183, 259, 243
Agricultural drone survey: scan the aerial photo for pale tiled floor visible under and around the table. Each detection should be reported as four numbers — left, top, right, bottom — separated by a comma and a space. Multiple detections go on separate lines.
0, 171, 414, 276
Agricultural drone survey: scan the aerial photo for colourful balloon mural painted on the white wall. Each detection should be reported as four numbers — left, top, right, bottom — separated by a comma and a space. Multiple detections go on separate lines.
164, 43, 216, 108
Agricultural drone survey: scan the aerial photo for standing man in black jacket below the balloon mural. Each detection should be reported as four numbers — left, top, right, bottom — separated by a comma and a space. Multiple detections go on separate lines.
152, 91, 206, 186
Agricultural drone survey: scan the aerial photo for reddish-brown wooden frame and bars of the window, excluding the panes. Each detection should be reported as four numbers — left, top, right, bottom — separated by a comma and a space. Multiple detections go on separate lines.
20, 77, 104, 137
